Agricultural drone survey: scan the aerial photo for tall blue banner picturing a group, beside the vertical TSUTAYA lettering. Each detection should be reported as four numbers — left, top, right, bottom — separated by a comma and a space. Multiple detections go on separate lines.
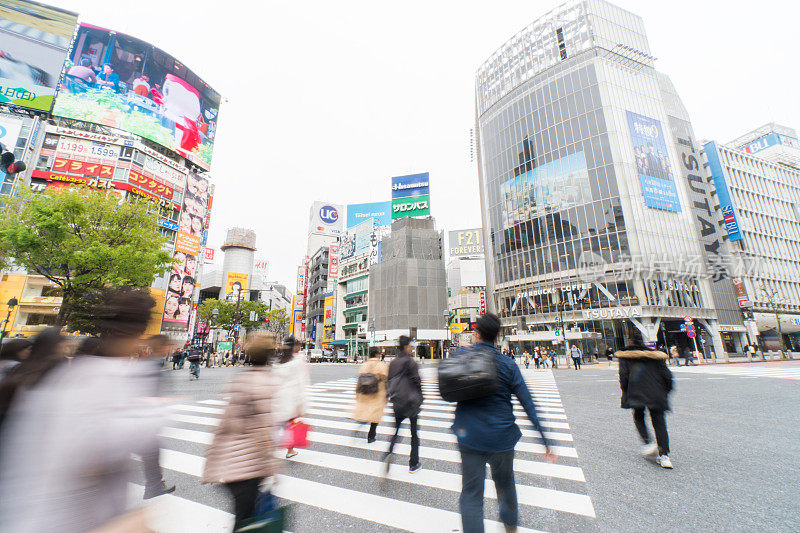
626, 111, 681, 212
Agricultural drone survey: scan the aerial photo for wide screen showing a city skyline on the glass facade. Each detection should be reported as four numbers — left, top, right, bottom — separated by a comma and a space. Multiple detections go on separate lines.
500, 152, 592, 228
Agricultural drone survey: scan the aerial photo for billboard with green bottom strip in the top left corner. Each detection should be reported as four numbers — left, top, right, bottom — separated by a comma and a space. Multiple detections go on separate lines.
0, 0, 78, 111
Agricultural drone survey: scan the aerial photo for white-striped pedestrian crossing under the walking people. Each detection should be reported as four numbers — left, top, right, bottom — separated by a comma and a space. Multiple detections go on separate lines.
130, 368, 595, 533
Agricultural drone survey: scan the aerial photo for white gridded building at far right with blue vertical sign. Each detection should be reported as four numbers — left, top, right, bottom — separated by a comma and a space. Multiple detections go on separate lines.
704, 124, 800, 350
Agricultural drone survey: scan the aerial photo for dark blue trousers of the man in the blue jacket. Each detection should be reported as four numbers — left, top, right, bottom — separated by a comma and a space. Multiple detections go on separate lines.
458, 446, 519, 533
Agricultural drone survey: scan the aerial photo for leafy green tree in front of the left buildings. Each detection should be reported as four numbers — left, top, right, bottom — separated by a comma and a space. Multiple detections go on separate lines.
0, 187, 172, 332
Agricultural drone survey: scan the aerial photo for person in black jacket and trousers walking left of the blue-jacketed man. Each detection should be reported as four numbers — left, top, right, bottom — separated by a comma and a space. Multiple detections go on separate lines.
383, 335, 422, 477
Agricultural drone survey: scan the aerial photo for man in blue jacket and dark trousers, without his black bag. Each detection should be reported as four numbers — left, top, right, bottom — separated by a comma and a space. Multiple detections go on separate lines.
452, 314, 557, 533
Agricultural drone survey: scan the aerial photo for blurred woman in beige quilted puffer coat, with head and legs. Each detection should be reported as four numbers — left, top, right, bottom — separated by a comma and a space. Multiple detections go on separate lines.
201, 333, 278, 528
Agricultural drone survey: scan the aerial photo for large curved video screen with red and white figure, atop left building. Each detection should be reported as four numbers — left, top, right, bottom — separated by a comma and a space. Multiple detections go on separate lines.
53, 24, 220, 169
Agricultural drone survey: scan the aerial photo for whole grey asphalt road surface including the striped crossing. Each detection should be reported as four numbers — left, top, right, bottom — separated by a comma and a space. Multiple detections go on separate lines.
131, 363, 800, 533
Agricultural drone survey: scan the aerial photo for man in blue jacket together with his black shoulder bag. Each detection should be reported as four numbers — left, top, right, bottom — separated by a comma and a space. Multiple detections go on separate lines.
439, 314, 557, 533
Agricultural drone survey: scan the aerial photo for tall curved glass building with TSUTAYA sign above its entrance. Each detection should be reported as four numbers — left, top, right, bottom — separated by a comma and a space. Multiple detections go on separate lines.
476, 0, 744, 355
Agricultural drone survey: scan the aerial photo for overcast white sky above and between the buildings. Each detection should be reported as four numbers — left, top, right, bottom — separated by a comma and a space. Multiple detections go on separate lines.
48, 0, 800, 289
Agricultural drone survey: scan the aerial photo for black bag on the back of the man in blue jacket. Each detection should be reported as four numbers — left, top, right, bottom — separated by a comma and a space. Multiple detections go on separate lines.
438, 345, 498, 402
